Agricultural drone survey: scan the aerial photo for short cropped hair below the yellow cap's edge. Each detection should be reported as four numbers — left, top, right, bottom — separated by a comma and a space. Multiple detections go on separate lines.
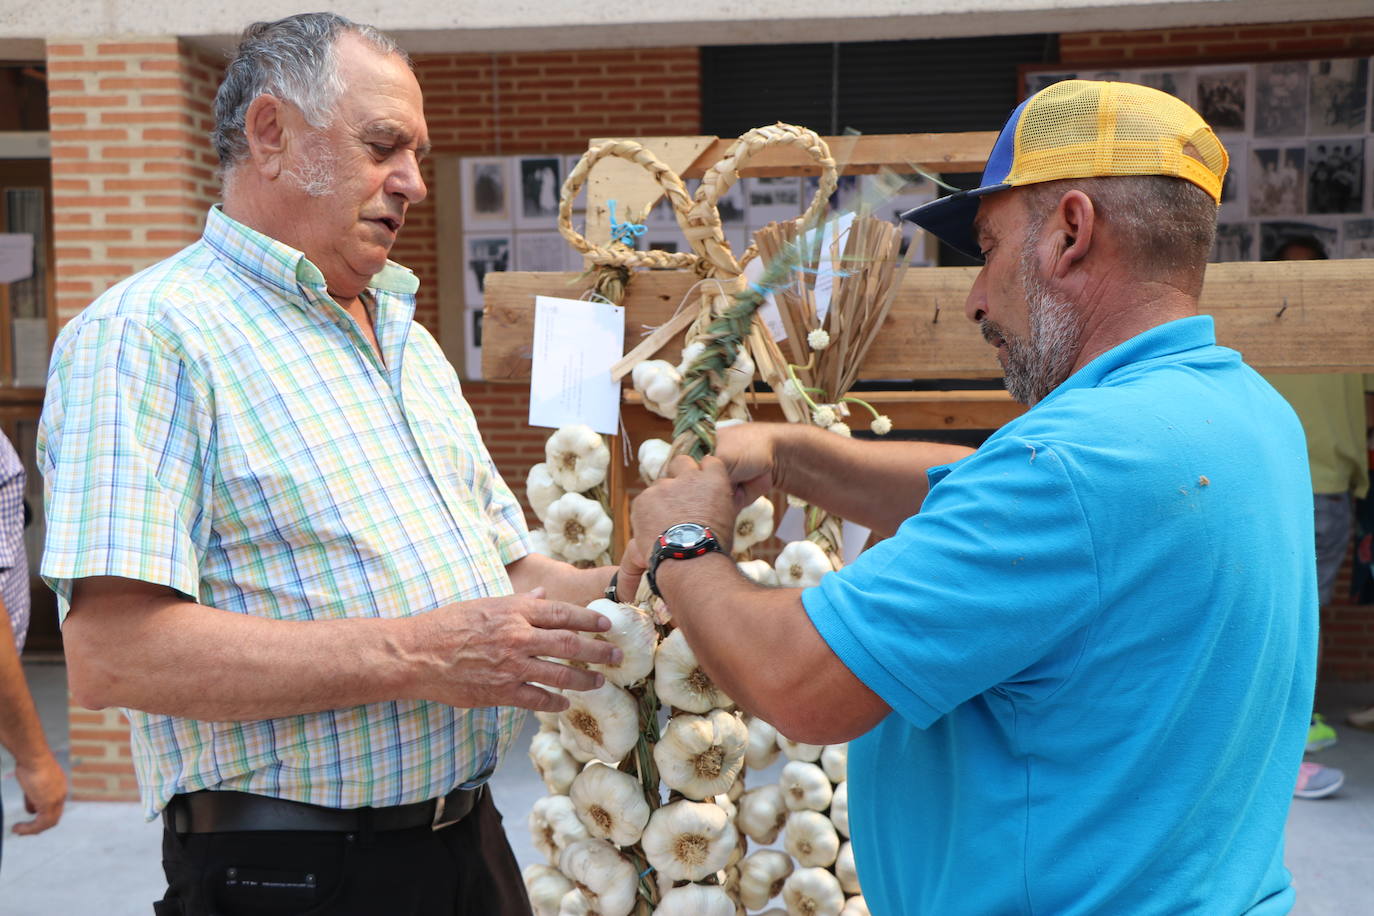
1021, 174, 1216, 279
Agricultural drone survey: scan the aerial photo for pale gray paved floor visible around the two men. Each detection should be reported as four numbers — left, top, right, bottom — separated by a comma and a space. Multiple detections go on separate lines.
0, 663, 1374, 916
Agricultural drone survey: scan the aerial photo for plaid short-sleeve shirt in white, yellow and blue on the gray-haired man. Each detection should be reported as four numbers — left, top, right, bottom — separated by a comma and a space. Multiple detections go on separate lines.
38, 207, 529, 818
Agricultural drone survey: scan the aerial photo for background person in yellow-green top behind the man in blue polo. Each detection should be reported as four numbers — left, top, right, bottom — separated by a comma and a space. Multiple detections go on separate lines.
1265, 235, 1374, 798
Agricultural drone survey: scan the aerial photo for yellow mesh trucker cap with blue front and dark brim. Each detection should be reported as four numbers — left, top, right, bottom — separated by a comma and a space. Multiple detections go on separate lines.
901, 80, 1227, 260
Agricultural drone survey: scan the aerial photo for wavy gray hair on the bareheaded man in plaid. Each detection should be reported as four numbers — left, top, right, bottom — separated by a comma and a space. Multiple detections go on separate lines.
210, 12, 411, 169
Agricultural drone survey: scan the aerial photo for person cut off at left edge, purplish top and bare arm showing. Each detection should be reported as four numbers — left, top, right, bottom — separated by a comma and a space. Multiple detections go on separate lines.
0, 435, 67, 873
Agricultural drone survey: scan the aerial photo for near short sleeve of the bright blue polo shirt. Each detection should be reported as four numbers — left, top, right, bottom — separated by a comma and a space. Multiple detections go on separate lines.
802, 437, 1099, 728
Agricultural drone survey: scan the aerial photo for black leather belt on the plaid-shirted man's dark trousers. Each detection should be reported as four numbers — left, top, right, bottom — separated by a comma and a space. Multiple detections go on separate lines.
162, 786, 482, 834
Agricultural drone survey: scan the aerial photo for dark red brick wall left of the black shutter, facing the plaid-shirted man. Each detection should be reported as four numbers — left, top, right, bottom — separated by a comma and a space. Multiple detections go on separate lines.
393, 48, 701, 521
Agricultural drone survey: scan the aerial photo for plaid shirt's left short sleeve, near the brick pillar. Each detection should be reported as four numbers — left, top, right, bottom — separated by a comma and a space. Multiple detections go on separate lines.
41, 317, 213, 618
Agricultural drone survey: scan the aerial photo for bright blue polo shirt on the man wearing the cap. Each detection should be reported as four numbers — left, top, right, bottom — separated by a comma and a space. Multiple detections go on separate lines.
802, 316, 1318, 916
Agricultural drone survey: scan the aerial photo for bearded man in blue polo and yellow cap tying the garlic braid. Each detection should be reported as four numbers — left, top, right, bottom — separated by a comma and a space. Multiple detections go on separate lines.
622, 81, 1316, 916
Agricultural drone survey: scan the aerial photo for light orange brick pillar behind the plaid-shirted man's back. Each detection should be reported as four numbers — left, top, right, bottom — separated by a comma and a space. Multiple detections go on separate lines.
48, 38, 220, 799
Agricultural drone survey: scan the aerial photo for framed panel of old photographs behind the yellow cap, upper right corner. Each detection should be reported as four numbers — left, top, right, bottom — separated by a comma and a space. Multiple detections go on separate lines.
1022, 56, 1374, 261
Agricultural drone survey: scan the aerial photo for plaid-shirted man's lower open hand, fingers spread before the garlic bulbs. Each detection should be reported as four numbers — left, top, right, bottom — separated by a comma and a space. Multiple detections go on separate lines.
411, 589, 620, 713
